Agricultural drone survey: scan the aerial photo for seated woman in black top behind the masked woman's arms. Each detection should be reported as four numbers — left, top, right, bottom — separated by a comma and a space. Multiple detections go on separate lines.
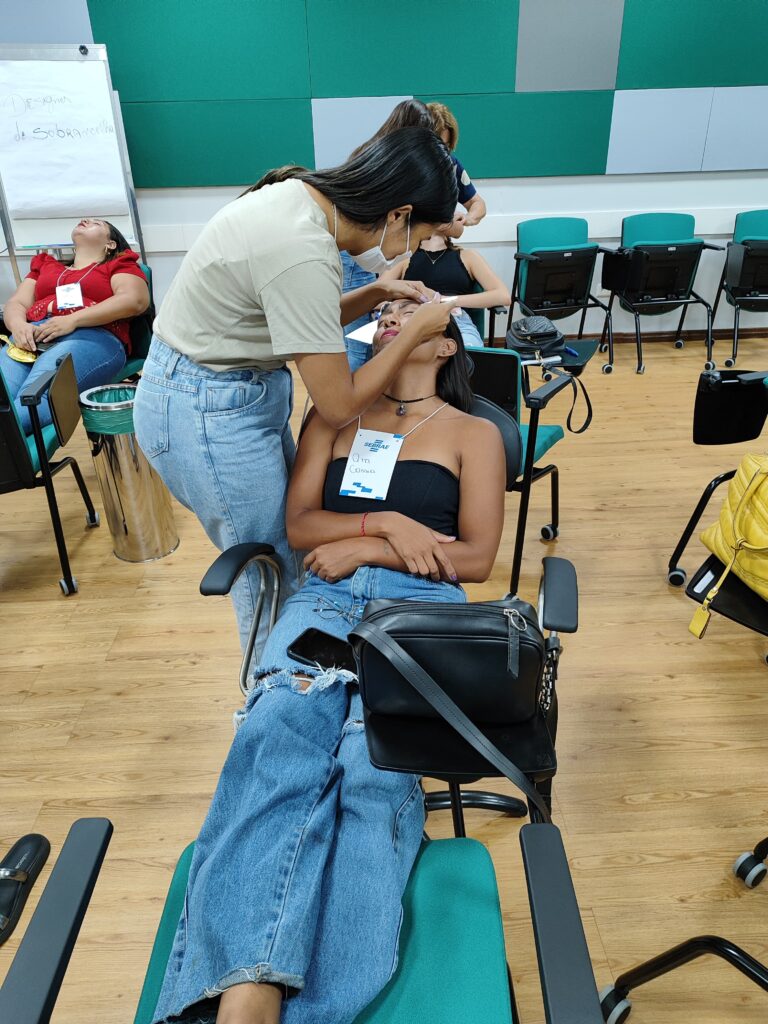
381, 222, 512, 348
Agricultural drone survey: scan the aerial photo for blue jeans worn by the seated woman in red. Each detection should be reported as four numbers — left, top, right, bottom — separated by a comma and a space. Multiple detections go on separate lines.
0, 321, 125, 434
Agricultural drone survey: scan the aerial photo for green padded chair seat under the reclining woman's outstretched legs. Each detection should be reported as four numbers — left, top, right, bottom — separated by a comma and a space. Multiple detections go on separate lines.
134, 839, 513, 1024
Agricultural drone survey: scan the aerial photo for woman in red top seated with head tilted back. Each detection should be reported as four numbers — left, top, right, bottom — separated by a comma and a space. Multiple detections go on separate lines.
0, 218, 150, 433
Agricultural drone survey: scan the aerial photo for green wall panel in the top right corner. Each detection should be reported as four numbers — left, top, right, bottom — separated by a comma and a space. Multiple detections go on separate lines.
616, 0, 768, 89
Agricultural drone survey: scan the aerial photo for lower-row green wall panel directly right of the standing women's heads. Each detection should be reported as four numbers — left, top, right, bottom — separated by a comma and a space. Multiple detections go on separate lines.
419, 90, 613, 178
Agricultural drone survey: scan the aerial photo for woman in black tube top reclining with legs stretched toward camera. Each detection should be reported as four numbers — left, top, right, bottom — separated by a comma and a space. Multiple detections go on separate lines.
156, 300, 506, 1024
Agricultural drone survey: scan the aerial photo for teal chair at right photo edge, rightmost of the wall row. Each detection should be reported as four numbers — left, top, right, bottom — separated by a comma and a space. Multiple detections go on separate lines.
712, 210, 768, 369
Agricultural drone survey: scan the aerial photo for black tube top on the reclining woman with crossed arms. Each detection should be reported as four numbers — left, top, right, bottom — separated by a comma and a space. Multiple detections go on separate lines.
323, 458, 459, 537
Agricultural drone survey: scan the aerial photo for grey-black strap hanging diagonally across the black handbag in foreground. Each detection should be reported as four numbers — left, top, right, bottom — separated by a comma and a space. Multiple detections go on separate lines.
350, 620, 552, 822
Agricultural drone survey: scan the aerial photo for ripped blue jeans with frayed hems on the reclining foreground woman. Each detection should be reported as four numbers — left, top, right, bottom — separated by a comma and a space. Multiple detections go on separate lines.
155, 566, 466, 1024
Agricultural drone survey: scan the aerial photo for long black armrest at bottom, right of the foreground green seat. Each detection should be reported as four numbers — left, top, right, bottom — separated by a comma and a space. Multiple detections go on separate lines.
520, 823, 603, 1024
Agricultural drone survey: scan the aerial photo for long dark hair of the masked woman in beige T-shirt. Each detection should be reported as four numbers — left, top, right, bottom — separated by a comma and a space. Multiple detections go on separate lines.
243, 128, 459, 230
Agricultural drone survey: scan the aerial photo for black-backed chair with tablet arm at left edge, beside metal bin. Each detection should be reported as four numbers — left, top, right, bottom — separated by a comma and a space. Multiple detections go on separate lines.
0, 355, 99, 597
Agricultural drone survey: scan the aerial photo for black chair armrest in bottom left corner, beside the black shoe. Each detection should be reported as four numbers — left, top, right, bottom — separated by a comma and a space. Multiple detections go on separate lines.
0, 818, 113, 1024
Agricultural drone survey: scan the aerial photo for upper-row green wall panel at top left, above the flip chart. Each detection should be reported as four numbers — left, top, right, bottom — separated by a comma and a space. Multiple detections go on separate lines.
88, 0, 309, 102
